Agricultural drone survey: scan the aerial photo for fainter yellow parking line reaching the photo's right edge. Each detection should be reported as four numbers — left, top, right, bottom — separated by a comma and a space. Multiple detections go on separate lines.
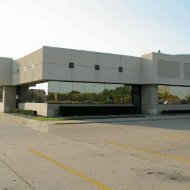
107, 141, 190, 164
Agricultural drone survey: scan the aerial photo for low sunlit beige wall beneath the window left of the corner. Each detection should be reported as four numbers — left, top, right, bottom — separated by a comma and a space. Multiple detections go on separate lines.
19, 103, 48, 116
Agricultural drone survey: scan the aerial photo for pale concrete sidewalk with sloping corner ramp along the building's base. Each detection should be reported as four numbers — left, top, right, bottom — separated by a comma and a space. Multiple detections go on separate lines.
0, 114, 190, 133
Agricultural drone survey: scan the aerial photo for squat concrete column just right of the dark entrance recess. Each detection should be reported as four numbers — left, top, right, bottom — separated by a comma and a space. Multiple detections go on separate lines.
141, 85, 158, 115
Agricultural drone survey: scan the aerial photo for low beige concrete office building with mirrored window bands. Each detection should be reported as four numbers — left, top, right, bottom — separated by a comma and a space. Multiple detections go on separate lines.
0, 46, 190, 116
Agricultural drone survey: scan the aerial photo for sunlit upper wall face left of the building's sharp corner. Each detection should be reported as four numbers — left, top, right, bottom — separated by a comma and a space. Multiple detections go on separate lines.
12, 48, 43, 85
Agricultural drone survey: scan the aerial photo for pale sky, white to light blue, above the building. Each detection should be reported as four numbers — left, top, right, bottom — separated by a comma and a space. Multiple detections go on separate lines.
0, 0, 190, 59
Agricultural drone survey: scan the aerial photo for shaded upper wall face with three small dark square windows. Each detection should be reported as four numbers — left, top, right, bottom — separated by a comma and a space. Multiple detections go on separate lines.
43, 47, 141, 84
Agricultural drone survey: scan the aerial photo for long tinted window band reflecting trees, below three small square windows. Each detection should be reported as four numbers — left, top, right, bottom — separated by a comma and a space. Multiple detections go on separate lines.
48, 81, 131, 104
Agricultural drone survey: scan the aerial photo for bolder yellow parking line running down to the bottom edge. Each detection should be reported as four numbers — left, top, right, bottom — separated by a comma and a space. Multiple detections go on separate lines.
29, 149, 112, 190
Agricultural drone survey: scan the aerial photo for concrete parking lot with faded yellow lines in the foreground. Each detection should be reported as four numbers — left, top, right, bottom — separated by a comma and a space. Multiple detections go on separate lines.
0, 117, 190, 190
